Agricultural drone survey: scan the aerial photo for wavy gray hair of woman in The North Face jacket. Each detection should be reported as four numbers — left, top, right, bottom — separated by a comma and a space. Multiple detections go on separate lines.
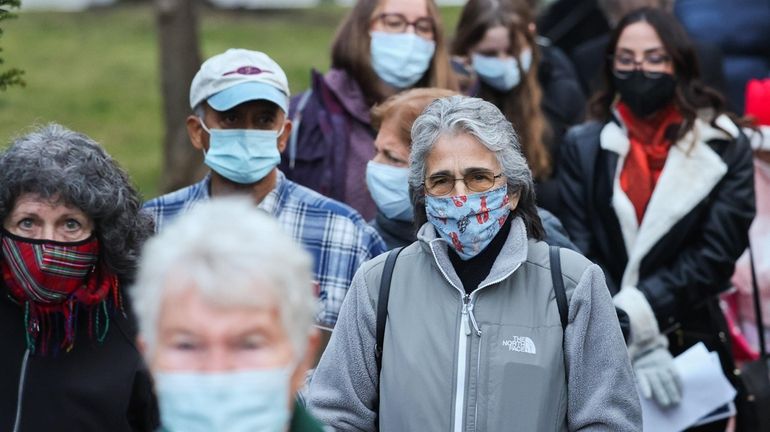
409, 96, 545, 240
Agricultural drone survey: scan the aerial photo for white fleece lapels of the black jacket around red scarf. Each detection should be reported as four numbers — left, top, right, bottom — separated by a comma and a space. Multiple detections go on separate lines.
599, 109, 728, 288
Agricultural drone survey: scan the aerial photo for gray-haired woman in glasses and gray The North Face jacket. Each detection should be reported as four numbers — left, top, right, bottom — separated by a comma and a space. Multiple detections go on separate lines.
308, 96, 641, 431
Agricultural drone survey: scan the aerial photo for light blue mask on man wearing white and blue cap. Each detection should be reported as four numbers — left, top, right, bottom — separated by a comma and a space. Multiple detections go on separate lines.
199, 118, 283, 184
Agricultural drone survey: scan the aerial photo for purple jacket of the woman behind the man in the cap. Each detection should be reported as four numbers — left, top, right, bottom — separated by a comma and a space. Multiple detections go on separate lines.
280, 69, 377, 220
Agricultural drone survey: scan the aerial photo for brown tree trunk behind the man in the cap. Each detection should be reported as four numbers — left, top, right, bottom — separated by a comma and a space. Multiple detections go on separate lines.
155, 0, 205, 192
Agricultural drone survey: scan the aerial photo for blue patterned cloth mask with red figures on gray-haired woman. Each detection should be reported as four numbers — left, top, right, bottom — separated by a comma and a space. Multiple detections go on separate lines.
425, 186, 511, 260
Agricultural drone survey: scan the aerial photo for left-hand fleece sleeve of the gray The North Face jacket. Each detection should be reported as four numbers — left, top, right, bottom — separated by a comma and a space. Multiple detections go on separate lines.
307, 265, 382, 431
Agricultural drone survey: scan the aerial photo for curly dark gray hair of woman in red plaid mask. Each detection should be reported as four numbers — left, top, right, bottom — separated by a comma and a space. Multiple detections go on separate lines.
0, 123, 153, 282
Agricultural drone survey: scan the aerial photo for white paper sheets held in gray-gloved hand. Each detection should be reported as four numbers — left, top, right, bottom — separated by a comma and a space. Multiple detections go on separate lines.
639, 343, 735, 432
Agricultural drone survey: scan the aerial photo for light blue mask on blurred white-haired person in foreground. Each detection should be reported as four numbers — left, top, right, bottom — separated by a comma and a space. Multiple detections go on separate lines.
154, 367, 291, 432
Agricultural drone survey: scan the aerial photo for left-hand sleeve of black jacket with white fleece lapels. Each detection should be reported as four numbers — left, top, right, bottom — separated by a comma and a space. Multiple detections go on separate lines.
557, 127, 594, 259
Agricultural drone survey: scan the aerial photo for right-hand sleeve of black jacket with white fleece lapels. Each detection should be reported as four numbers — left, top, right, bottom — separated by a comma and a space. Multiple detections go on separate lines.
638, 135, 755, 325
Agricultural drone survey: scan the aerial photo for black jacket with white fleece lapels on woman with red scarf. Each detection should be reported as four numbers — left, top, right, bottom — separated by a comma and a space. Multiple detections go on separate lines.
559, 116, 755, 362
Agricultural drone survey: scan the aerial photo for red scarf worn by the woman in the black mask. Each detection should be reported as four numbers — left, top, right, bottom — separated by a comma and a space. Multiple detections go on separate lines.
617, 102, 682, 223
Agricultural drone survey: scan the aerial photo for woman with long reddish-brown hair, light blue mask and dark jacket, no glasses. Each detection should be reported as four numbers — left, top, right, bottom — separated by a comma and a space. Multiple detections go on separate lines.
450, 0, 585, 214
